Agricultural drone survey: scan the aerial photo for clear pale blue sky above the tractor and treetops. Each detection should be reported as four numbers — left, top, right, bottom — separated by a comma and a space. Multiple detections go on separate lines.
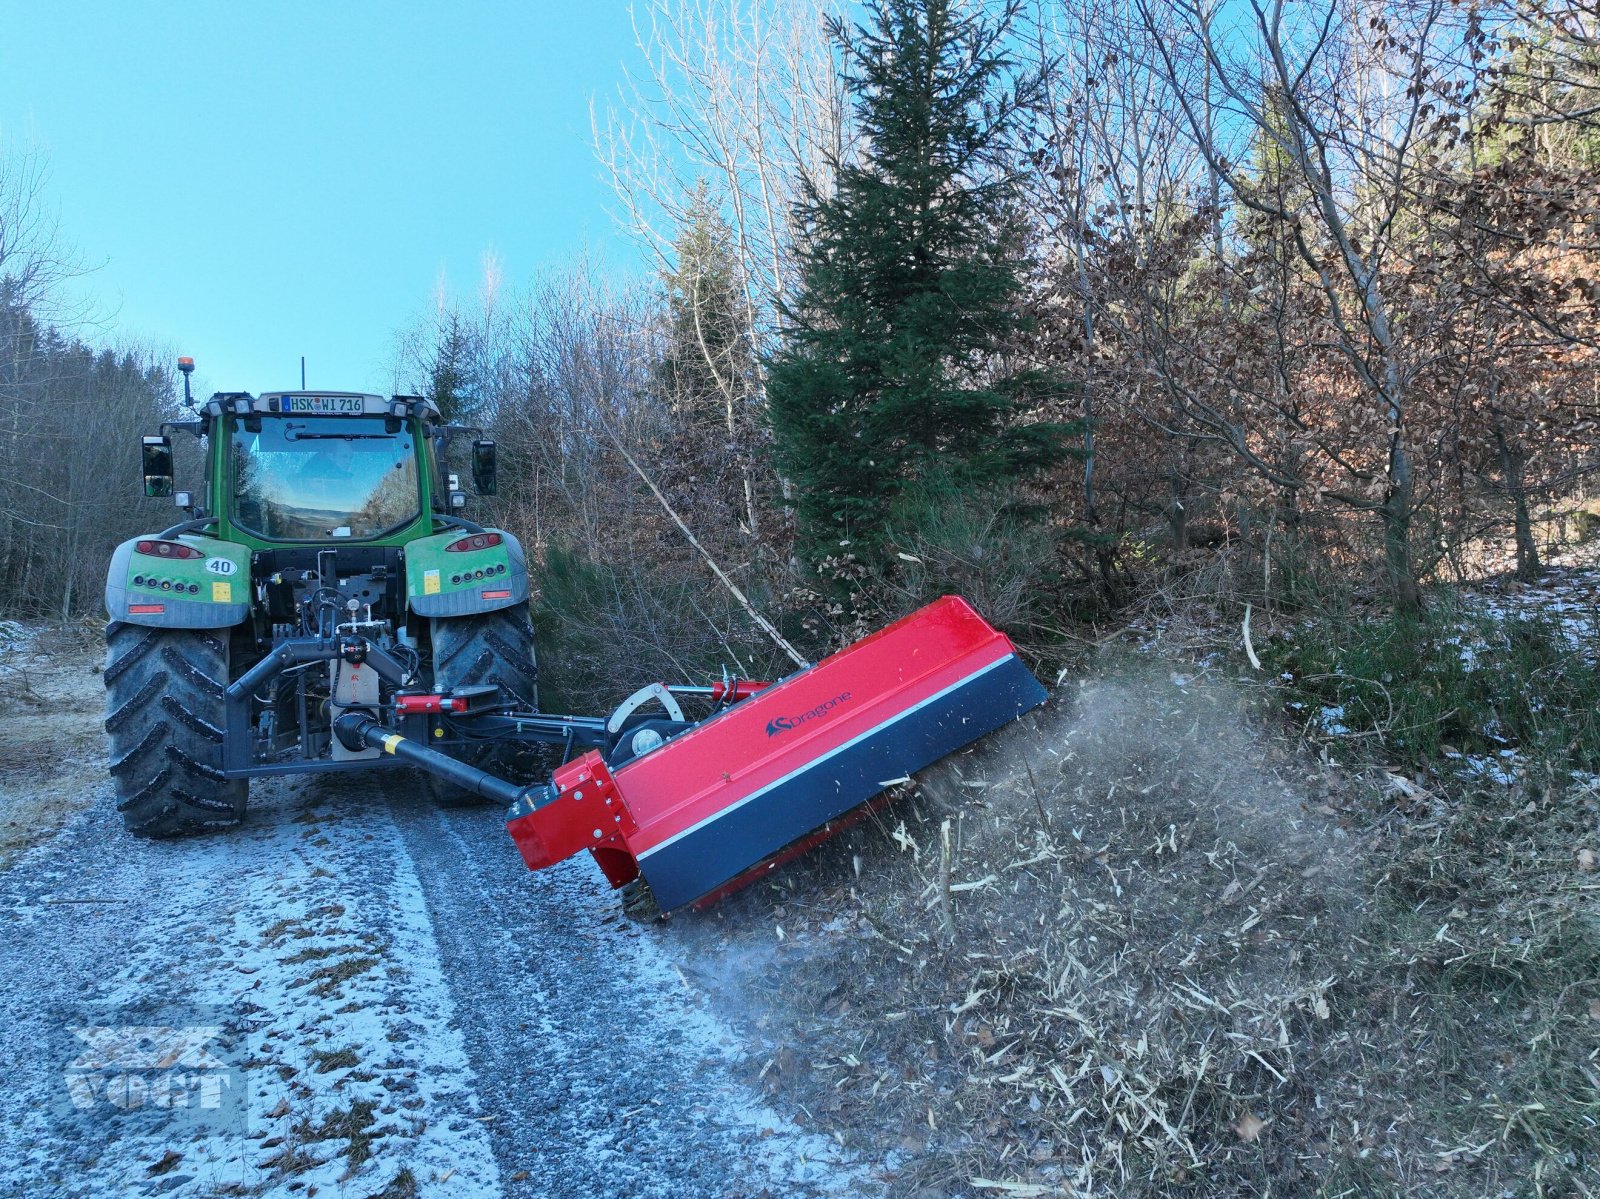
0, 0, 637, 392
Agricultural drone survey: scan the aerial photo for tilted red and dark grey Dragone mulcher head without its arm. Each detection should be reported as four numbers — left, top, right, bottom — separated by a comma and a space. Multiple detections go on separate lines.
507, 597, 1045, 911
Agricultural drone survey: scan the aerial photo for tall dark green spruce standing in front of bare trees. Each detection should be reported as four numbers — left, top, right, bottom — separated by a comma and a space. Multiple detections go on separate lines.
768, 0, 1074, 555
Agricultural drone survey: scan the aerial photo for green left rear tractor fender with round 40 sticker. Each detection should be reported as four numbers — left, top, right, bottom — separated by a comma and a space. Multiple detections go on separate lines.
106, 533, 250, 629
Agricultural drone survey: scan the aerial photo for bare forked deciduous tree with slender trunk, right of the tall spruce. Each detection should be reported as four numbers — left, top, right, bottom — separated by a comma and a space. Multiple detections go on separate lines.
1120, 0, 1478, 607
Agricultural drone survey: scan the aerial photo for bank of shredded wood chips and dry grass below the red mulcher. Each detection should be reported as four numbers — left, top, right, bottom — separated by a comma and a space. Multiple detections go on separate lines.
675, 672, 1600, 1199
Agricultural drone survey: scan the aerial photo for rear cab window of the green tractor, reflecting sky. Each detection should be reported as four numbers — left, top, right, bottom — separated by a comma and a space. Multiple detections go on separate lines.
232, 416, 421, 541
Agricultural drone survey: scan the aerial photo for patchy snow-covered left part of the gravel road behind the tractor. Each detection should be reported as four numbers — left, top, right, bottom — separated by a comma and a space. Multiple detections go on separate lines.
0, 776, 499, 1197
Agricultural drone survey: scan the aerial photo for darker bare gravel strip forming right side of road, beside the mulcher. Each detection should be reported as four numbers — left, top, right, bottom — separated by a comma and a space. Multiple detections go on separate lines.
386, 775, 880, 1199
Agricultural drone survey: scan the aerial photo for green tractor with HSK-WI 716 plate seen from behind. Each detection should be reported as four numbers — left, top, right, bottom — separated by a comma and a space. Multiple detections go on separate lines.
106, 359, 538, 837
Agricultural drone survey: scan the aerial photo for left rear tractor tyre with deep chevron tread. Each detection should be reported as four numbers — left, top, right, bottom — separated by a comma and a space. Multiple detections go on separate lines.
106, 621, 250, 837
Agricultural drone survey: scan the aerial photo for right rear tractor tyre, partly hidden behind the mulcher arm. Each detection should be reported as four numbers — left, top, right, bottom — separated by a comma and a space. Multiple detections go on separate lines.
422, 605, 544, 807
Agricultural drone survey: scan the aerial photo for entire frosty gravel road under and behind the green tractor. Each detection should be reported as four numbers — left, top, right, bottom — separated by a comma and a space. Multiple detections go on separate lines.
0, 697, 880, 1199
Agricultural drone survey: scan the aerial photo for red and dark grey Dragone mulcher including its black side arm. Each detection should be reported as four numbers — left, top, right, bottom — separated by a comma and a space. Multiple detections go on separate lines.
334, 595, 1045, 911
